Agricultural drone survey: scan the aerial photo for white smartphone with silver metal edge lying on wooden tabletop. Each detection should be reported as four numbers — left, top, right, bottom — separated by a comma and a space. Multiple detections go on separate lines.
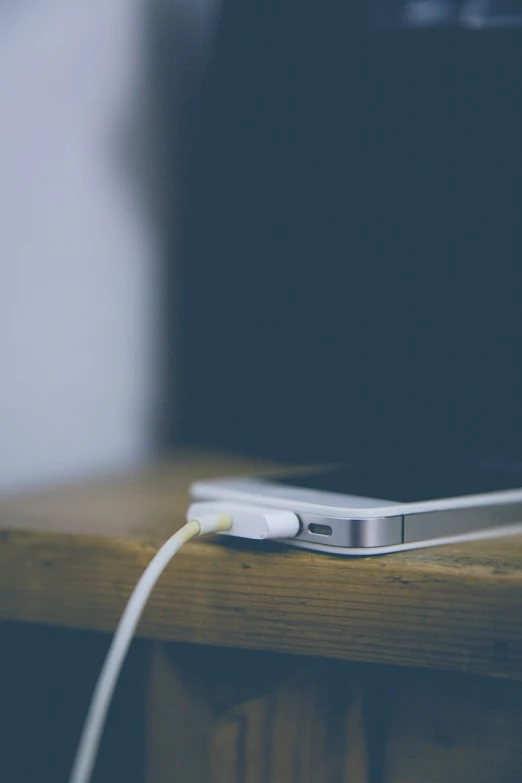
191, 459, 522, 555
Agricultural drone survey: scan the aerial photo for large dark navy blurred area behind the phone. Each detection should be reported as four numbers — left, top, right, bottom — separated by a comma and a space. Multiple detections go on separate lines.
159, 0, 522, 472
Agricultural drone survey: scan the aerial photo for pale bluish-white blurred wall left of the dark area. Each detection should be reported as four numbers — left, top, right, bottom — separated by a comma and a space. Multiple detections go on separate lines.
0, 0, 156, 490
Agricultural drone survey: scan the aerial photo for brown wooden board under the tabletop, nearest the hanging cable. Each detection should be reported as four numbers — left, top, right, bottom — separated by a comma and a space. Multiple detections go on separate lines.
147, 645, 366, 783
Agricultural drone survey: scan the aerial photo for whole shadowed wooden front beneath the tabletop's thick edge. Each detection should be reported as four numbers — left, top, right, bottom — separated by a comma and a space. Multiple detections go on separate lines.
147, 644, 522, 783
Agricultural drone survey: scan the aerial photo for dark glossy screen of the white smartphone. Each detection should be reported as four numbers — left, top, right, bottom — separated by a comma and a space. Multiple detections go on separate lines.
273, 460, 522, 503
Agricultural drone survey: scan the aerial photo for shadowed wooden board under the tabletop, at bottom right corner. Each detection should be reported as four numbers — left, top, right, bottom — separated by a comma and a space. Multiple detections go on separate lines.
376, 671, 522, 783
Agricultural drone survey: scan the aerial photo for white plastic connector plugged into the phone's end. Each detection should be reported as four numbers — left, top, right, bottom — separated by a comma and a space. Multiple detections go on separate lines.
187, 501, 300, 541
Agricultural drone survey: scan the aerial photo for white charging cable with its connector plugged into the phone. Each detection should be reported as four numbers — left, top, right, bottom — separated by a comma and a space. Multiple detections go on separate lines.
69, 503, 299, 783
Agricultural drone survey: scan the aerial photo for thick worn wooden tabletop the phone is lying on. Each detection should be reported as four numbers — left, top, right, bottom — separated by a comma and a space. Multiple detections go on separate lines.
0, 456, 522, 678
